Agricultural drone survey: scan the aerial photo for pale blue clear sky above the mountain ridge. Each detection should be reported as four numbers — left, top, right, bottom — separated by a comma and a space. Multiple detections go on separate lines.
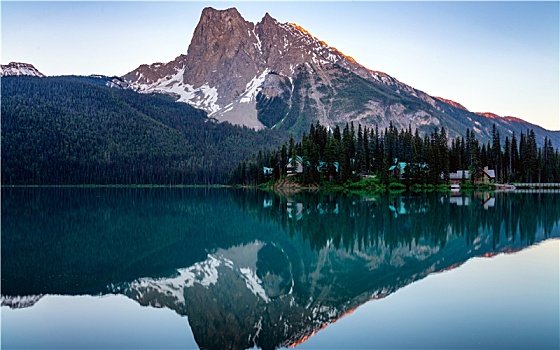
0, 0, 560, 130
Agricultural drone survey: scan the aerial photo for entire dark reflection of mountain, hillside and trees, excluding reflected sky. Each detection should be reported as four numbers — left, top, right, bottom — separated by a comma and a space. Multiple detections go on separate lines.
2, 188, 560, 349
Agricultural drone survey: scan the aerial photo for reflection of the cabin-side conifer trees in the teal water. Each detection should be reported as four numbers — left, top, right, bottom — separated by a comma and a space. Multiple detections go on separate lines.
248, 192, 560, 250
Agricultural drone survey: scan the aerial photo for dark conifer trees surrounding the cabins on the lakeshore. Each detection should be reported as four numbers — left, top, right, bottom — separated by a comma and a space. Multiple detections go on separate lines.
231, 122, 560, 185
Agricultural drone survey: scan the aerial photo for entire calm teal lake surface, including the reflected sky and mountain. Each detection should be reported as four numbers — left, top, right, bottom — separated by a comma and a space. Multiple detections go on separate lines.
1, 188, 560, 349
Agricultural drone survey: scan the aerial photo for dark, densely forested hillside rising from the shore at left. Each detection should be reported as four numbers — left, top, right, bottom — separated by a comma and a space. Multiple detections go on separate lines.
1, 76, 285, 185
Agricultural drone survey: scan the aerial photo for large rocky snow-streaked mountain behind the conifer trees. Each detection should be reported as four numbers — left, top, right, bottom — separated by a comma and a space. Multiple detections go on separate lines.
122, 8, 560, 147
